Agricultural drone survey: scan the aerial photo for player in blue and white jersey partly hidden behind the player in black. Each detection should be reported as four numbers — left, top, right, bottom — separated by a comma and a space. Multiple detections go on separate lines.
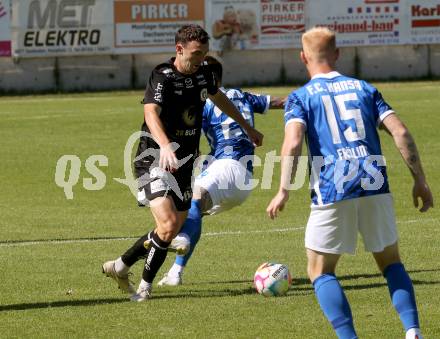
158, 56, 286, 286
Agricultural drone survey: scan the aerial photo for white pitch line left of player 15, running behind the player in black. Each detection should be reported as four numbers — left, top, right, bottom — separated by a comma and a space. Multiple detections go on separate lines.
0, 227, 304, 248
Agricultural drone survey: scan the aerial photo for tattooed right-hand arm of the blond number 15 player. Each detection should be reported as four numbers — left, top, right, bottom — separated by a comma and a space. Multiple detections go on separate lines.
382, 114, 434, 212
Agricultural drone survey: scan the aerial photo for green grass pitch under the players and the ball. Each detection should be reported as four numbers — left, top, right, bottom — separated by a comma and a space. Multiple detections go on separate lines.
0, 82, 440, 338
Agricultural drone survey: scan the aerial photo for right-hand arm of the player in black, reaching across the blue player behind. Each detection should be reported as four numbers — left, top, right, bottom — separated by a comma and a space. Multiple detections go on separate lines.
208, 91, 264, 146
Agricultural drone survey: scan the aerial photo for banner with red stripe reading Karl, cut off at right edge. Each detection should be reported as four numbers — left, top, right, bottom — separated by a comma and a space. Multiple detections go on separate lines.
406, 0, 440, 44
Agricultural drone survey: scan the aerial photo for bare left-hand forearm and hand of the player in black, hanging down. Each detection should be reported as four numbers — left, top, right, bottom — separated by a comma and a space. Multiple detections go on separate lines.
144, 104, 178, 172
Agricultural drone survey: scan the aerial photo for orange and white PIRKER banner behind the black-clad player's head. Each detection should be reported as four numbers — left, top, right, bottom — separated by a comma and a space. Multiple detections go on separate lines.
114, 0, 205, 53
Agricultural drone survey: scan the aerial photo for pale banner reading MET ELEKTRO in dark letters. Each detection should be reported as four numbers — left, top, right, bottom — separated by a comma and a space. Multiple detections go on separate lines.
12, 0, 113, 57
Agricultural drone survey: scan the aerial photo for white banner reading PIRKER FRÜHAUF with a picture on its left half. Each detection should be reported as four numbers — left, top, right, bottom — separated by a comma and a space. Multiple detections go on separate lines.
205, 0, 305, 52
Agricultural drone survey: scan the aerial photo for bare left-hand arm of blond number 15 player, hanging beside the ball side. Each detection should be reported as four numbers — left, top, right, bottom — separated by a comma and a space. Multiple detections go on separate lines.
266, 122, 305, 219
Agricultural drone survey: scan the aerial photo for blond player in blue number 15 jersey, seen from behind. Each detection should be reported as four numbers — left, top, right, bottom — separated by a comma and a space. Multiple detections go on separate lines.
267, 27, 433, 339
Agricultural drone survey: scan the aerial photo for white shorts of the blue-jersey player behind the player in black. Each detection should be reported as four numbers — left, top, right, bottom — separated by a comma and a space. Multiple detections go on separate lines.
194, 159, 252, 215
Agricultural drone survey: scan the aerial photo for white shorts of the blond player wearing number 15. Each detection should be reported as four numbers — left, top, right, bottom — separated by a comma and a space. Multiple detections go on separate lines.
305, 193, 397, 254
